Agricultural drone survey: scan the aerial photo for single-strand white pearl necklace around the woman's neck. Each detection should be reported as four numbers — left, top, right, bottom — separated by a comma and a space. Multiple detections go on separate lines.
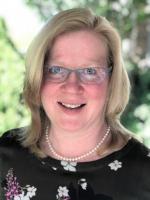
45, 126, 110, 162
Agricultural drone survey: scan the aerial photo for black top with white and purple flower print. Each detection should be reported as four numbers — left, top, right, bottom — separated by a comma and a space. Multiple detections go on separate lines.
0, 129, 150, 200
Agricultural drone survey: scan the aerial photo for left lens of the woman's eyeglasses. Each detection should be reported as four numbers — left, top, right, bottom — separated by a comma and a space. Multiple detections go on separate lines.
45, 66, 68, 83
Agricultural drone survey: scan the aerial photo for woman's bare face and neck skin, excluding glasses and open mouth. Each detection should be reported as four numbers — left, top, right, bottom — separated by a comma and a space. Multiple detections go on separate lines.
41, 30, 109, 159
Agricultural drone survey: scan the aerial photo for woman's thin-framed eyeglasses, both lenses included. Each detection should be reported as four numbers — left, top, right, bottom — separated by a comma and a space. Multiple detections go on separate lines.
44, 65, 112, 84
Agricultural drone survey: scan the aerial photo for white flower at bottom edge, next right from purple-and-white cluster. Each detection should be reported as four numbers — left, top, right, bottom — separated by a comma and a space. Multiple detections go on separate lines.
56, 186, 70, 200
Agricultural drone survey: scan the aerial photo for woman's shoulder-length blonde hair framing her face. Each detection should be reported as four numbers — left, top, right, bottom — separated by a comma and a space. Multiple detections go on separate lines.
22, 8, 130, 155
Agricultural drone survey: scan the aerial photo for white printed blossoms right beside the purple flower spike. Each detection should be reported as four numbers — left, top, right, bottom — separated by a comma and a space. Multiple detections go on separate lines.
14, 185, 37, 200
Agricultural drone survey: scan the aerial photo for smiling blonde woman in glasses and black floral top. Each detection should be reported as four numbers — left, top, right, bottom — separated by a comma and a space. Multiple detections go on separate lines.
0, 8, 150, 200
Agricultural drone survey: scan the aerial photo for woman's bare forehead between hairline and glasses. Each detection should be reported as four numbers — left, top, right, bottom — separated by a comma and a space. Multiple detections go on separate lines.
49, 30, 108, 65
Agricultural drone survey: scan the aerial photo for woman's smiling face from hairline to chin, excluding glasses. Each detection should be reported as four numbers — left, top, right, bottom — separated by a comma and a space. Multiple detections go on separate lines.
41, 31, 109, 131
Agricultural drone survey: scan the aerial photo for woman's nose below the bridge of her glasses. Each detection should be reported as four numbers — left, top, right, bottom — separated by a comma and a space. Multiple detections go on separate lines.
62, 71, 83, 94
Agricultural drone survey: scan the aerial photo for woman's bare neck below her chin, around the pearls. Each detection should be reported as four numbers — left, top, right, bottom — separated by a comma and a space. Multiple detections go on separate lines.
42, 124, 109, 160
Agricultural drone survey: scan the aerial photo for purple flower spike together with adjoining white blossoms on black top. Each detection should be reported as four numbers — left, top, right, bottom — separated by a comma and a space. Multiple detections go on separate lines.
4, 168, 37, 200
